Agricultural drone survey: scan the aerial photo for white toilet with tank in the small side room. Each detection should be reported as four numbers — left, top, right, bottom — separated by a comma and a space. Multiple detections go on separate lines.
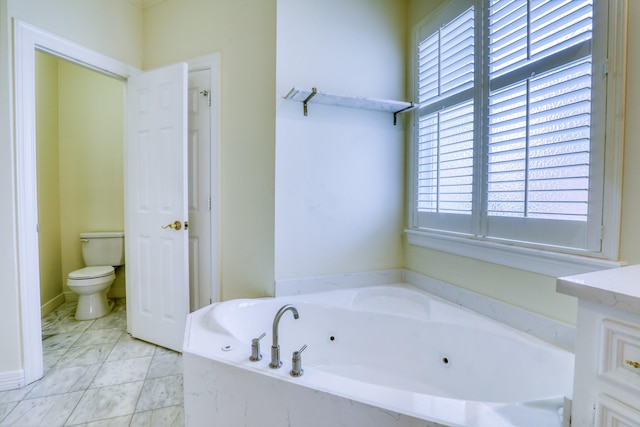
67, 232, 124, 320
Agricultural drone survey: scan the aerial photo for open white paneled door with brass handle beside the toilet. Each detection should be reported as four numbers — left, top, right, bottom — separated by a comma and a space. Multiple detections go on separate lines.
125, 64, 189, 351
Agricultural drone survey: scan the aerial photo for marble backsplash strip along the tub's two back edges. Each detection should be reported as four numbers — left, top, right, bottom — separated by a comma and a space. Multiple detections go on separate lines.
275, 269, 576, 352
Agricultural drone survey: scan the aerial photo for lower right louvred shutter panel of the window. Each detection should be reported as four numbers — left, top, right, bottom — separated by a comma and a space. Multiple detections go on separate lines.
487, 62, 591, 221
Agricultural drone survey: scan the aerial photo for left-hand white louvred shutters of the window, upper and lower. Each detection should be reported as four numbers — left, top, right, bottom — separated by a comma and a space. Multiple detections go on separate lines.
416, 2, 475, 232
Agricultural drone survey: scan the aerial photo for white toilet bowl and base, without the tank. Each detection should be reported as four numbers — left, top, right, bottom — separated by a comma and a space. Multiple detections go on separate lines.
67, 265, 116, 320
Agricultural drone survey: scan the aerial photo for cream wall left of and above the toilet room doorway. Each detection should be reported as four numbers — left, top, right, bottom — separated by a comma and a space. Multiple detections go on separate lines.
0, 0, 142, 382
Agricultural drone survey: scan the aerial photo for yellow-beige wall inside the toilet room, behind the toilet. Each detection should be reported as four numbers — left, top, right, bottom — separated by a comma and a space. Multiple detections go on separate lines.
36, 52, 125, 304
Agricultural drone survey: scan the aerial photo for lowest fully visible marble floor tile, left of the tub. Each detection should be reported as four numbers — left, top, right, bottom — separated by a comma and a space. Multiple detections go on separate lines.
67, 381, 143, 425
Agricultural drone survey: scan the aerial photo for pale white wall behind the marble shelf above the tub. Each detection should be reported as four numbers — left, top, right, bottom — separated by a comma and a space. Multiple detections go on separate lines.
275, 0, 406, 279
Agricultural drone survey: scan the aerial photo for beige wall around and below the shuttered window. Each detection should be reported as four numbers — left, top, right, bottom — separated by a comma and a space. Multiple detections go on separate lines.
405, 0, 640, 324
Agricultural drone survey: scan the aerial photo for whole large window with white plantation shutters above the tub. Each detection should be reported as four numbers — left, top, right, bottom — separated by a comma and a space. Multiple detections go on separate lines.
410, 0, 624, 268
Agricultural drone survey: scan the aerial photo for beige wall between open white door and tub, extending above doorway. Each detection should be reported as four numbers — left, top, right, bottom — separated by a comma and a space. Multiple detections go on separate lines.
144, 0, 276, 299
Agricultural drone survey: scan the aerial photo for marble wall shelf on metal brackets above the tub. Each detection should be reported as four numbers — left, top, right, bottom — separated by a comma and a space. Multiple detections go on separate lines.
284, 87, 414, 125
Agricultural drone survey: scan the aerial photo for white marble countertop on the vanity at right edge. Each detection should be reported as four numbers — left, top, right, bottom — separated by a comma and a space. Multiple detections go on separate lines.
556, 265, 640, 314
